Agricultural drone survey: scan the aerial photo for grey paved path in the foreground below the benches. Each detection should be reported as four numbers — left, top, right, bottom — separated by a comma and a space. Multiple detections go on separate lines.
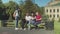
0, 27, 54, 34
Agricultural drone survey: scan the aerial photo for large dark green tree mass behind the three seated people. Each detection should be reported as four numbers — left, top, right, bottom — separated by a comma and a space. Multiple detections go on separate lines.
19, 0, 44, 18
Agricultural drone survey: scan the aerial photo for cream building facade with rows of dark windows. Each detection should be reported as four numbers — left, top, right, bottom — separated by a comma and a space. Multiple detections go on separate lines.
44, 0, 60, 20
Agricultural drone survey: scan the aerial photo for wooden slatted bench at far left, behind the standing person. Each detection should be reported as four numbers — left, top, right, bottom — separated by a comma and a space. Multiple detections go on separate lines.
0, 20, 20, 27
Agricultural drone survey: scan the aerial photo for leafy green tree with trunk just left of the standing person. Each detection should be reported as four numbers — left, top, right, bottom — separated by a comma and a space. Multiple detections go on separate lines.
6, 1, 18, 20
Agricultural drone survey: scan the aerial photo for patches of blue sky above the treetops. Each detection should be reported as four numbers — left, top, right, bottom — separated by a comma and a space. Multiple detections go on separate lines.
2, 0, 51, 7
